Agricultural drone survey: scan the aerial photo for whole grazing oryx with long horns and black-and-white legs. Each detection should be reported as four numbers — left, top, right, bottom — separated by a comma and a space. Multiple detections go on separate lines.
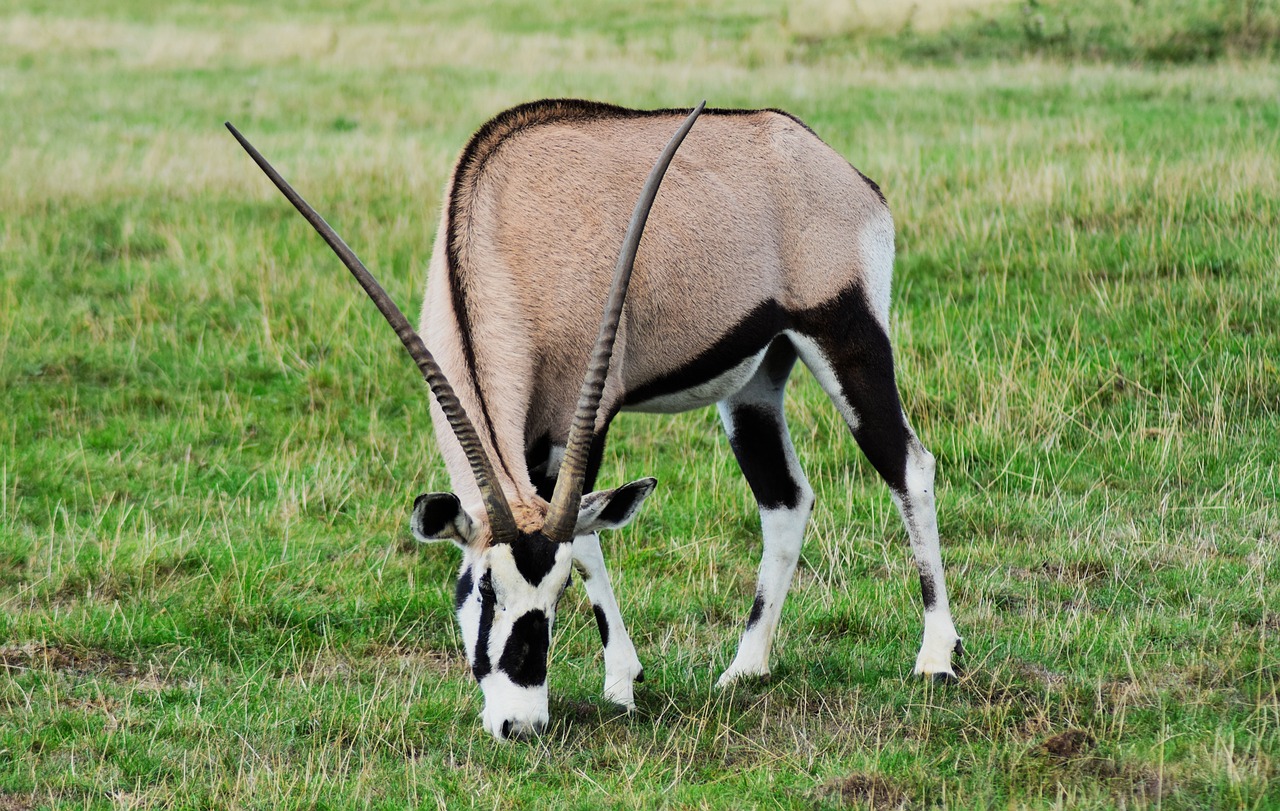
227, 100, 961, 739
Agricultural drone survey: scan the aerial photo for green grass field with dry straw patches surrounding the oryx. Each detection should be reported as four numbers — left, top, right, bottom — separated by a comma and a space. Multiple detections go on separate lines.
0, 0, 1280, 811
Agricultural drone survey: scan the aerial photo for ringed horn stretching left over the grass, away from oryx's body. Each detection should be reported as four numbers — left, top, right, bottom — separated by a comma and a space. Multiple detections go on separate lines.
227, 122, 516, 541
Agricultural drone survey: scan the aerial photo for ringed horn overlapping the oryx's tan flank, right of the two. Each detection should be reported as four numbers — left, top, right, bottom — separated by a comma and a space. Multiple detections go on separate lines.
543, 101, 707, 542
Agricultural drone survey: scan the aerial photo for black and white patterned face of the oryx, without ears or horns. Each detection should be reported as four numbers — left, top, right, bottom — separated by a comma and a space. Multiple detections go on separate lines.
454, 533, 573, 738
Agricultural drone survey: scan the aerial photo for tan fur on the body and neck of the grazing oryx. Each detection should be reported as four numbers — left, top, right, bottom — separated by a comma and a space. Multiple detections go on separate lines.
421, 102, 893, 529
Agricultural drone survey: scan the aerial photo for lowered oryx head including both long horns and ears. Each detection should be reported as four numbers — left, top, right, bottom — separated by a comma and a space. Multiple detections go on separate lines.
235, 102, 705, 739
